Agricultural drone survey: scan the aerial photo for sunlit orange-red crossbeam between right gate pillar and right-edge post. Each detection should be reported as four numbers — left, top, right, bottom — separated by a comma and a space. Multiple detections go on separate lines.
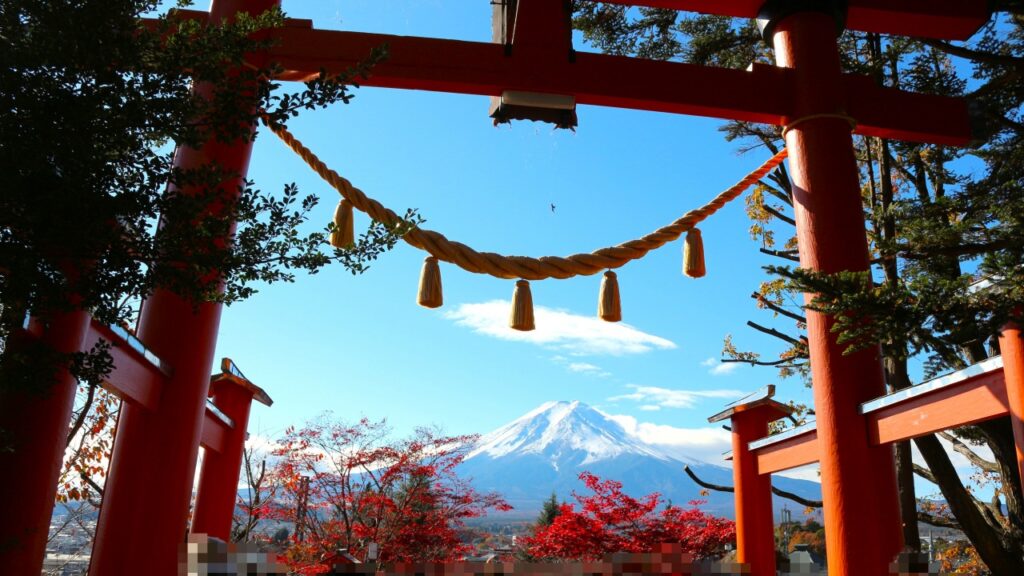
867, 370, 1008, 444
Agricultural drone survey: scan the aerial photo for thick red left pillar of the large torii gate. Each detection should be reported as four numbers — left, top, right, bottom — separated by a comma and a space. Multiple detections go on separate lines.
91, 0, 280, 576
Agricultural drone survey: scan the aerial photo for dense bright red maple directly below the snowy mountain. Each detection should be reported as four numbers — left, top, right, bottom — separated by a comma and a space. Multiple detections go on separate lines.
522, 472, 736, 561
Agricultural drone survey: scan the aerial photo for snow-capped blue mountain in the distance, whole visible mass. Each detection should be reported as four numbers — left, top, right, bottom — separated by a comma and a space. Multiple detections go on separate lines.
459, 401, 821, 518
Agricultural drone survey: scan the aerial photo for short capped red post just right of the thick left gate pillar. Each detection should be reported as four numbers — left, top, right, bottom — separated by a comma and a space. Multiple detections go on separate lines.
191, 359, 271, 542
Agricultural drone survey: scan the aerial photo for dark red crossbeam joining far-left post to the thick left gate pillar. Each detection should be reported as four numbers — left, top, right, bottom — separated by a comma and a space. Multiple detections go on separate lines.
84, 320, 167, 410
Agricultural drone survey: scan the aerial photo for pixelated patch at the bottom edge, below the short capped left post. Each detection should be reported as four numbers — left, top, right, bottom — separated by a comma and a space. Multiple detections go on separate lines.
178, 534, 288, 576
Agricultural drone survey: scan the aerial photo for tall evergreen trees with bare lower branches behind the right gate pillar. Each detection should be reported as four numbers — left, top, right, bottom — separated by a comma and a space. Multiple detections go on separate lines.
575, 1, 1024, 574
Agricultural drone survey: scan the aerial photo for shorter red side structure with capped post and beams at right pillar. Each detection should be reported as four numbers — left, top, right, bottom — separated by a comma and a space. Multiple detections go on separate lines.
708, 313, 1024, 574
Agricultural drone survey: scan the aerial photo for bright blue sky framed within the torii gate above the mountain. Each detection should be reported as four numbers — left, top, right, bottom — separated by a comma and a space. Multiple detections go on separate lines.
207, 0, 809, 471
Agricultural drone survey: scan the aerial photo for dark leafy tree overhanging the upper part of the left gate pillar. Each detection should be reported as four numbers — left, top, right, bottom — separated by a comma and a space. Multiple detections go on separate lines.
0, 0, 411, 405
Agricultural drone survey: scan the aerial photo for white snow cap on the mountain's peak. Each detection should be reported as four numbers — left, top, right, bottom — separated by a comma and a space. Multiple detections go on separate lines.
466, 400, 670, 461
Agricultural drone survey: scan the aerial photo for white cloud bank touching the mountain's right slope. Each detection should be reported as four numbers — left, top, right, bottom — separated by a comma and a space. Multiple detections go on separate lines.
607, 414, 732, 465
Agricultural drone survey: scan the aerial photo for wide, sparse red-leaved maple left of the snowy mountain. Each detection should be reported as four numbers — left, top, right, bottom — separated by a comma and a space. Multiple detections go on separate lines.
261, 416, 511, 572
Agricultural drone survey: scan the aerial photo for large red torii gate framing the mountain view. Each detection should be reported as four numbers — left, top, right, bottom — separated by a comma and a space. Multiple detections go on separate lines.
0, 0, 989, 576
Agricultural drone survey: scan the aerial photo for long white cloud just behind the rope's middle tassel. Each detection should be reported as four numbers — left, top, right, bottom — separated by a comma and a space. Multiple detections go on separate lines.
444, 300, 676, 356
